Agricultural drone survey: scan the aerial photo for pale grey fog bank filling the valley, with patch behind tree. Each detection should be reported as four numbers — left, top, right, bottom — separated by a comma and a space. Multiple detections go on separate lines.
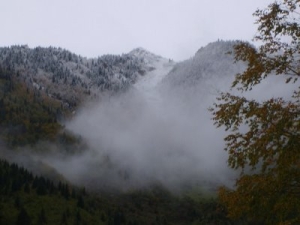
2, 42, 293, 193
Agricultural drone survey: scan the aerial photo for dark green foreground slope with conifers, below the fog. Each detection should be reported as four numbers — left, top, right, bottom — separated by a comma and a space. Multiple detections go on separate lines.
0, 160, 233, 225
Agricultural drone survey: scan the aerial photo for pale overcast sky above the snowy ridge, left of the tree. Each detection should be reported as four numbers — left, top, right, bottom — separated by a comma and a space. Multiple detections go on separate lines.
0, 0, 272, 61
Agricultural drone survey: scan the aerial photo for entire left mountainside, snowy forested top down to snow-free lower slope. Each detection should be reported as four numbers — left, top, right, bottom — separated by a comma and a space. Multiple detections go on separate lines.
0, 46, 162, 146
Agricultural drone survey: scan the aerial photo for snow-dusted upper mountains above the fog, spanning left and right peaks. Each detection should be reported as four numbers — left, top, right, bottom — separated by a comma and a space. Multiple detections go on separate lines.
0, 41, 244, 109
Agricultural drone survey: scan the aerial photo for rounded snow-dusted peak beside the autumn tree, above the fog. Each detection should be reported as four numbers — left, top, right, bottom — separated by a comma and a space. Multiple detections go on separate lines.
162, 41, 245, 93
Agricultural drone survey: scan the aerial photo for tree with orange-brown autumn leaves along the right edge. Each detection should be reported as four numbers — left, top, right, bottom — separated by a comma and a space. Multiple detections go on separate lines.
212, 0, 300, 225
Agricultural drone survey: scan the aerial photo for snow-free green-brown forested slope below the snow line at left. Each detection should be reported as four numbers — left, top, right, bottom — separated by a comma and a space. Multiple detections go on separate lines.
0, 67, 62, 146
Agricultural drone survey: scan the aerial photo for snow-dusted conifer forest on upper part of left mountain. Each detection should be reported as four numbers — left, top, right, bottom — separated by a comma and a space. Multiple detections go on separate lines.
0, 45, 159, 108
